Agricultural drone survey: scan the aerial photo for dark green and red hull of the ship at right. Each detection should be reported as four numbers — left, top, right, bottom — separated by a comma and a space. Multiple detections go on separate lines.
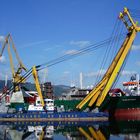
104, 96, 140, 120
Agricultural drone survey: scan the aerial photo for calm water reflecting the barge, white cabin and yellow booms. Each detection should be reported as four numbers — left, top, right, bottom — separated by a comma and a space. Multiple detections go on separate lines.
0, 121, 140, 140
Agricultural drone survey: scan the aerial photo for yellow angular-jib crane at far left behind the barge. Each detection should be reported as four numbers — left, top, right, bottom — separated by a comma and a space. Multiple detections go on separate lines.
0, 34, 27, 91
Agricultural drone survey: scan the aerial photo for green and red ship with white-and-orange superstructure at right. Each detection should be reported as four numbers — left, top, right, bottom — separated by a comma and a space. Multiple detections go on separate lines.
100, 76, 140, 120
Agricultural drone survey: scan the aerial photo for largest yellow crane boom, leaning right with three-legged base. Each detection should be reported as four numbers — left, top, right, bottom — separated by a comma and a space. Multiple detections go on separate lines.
76, 8, 140, 110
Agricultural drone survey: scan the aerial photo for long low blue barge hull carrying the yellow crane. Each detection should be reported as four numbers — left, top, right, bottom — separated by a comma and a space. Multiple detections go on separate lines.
0, 112, 108, 122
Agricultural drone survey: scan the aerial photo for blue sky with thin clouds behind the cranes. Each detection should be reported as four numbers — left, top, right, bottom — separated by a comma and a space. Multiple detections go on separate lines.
0, 0, 140, 87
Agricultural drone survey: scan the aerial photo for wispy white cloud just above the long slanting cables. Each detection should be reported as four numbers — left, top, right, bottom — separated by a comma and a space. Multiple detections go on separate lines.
70, 40, 91, 47
